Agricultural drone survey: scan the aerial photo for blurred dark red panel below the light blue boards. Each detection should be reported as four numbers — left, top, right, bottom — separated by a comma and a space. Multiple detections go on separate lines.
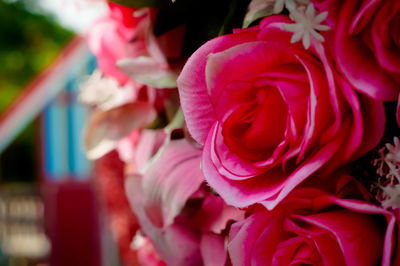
42, 179, 102, 266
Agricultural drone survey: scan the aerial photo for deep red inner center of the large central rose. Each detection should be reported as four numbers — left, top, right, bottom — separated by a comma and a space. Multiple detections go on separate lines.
222, 87, 288, 161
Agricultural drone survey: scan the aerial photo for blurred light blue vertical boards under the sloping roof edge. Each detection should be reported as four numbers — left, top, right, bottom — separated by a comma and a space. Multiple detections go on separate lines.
42, 55, 97, 180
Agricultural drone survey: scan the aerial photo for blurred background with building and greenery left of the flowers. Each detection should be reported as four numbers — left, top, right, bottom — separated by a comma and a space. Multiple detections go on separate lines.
0, 0, 126, 266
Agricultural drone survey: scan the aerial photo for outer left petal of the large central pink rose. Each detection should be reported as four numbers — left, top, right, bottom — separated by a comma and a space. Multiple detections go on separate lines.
177, 31, 257, 144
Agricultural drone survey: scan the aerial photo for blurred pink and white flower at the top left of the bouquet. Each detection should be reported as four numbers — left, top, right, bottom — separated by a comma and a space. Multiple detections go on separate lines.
88, 3, 185, 88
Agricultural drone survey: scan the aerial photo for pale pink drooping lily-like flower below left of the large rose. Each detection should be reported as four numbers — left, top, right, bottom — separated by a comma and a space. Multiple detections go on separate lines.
126, 136, 244, 266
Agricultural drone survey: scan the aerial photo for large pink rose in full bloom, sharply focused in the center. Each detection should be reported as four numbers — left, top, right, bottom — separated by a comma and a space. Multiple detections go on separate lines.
178, 16, 385, 209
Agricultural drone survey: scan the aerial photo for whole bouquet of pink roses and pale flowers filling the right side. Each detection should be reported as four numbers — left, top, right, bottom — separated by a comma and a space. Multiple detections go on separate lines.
80, 0, 400, 266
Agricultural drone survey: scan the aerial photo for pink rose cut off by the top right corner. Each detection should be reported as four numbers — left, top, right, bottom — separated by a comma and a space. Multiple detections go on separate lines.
313, 0, 400, 101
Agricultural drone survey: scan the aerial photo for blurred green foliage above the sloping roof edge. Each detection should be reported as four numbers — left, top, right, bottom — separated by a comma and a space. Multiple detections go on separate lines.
0, 0, 72, 113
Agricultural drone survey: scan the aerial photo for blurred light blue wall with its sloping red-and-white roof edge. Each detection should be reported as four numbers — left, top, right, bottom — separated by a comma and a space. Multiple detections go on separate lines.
0, 37, 97, 181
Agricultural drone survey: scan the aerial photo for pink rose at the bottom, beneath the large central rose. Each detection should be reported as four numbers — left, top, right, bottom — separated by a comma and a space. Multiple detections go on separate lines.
228, 189, 398, 266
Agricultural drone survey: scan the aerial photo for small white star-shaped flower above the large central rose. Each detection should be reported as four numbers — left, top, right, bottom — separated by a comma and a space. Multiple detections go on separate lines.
285, 3, 330, 49
